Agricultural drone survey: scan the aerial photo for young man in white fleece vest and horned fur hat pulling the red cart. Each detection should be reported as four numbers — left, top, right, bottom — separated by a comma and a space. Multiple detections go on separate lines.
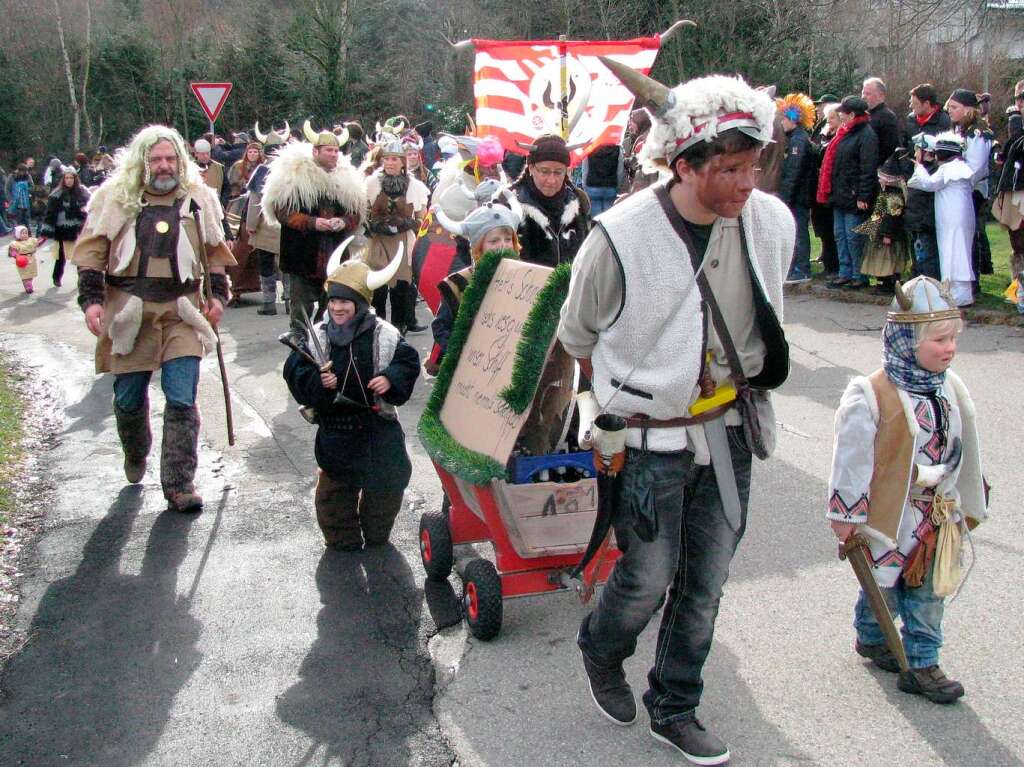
561, 57, 795, 765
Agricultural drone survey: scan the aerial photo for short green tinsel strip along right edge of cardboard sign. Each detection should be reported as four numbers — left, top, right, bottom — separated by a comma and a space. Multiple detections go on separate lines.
500, 263, 572, 414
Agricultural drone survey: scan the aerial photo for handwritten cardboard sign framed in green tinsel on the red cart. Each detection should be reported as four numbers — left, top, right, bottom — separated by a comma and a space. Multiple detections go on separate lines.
440, 259, 554, 463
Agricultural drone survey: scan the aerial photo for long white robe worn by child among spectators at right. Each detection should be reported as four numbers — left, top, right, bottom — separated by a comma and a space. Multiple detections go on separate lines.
907, 159, 975, 306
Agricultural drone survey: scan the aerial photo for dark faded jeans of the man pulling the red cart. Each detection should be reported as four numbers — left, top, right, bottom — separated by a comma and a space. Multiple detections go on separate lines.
579, 427, 751, 724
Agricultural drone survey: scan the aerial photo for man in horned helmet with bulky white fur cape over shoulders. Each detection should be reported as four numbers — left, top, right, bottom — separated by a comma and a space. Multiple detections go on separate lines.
262, 120, 367, 338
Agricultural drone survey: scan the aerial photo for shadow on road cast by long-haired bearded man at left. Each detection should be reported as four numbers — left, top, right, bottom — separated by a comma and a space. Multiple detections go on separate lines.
0, 486, 201, 767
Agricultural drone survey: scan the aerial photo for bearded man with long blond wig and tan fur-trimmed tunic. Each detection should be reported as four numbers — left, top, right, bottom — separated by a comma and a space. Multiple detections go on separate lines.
72, 125, 234, 512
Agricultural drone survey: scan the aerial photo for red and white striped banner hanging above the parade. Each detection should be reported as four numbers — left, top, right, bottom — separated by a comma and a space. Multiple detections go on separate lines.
473, 35, 660, 165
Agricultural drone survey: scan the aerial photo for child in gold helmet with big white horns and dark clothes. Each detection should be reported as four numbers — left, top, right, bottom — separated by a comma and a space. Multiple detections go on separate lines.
285, 243, 420, 551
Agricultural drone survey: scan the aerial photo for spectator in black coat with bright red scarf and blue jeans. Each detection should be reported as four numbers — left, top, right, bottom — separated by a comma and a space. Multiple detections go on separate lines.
817, 96, 879, 288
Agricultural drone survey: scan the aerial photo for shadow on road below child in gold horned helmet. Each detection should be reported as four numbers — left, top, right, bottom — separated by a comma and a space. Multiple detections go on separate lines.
276, 545, 451, 767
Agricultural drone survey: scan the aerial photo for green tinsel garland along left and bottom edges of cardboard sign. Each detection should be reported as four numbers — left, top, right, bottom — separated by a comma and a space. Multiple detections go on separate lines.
418, 250, 516, 484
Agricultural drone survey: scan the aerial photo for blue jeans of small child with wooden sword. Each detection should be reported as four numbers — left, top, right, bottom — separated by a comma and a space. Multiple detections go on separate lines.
853, 561, 944, 669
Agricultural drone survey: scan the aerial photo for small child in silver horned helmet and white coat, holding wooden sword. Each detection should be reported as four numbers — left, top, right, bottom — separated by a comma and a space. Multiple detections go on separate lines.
825, 276, 987, 704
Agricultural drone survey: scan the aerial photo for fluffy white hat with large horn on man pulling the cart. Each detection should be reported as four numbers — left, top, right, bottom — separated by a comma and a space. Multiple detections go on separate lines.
600, 56, 775, 172
